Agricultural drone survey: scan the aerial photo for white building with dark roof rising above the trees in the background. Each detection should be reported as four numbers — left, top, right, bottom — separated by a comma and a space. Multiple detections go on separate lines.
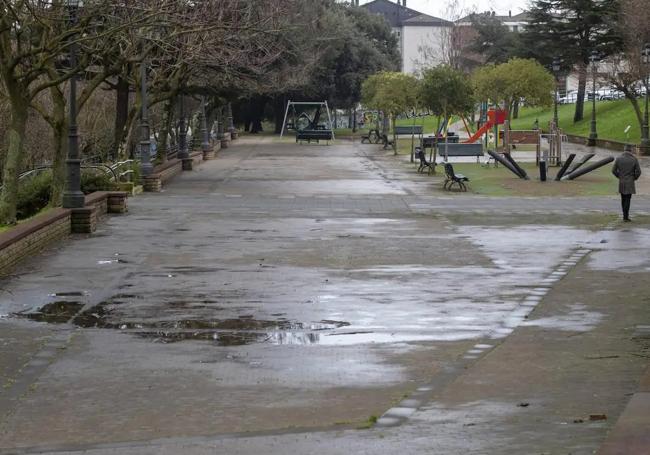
363, 0, 454, 73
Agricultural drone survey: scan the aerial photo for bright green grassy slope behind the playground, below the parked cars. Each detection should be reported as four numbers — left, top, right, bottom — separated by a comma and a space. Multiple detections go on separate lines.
512, 100, 641, 143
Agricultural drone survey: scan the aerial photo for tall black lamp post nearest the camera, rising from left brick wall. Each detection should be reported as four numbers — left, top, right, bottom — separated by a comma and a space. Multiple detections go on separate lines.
63, 0, 85, 209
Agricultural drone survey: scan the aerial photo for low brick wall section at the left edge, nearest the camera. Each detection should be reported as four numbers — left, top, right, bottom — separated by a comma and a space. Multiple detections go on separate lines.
0, 209, 71, 276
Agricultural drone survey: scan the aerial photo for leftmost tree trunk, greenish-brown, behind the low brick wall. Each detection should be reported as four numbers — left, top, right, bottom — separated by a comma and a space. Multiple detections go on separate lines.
0, 102, 29, 224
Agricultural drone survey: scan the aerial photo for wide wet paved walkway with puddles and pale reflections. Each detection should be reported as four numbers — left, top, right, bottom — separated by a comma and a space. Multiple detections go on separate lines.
0, 138, 650, 454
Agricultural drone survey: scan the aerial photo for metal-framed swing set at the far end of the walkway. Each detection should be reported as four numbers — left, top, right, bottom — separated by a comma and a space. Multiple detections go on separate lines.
280, 101, 334, 144
